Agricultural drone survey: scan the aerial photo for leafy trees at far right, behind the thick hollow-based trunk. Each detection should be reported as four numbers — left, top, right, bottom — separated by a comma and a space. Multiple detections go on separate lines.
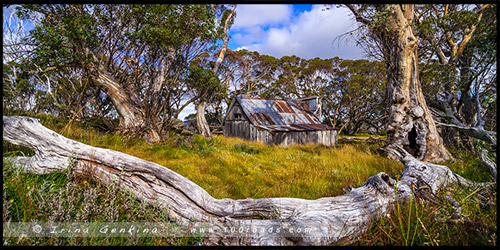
418, 4, 497, 144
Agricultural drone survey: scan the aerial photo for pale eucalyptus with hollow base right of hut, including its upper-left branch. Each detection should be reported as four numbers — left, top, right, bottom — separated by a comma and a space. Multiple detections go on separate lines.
346, 4, 451, 161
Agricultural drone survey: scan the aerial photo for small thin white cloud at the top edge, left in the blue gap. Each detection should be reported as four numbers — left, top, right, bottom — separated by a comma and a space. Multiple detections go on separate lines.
231, 4, 292, 30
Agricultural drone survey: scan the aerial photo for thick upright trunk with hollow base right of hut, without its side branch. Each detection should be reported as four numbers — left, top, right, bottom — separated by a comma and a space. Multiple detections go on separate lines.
384, 4, 451, 162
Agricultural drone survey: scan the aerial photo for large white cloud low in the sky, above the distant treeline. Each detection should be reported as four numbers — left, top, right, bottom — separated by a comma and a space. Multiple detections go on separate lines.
230, 5, 364, 59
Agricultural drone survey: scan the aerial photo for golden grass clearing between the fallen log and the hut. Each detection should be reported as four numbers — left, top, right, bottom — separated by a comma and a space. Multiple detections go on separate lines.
56, 130, 403, 199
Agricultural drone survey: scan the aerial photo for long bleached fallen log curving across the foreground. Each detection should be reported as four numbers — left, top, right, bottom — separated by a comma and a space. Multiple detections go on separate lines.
3, 116, 482, 245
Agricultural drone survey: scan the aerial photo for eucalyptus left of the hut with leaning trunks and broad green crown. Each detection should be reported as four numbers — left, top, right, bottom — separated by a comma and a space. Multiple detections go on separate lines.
14, 4, 232, 142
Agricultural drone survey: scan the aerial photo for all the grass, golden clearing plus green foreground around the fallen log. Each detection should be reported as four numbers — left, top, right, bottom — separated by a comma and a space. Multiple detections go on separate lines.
3, 115, 496, 245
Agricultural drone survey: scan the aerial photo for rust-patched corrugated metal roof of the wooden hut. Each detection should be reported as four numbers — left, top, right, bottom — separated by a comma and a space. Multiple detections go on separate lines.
229, 96, 334, 131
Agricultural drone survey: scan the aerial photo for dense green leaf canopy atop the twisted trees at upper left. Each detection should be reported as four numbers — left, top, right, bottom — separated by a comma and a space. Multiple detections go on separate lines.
18, 4, 221, 70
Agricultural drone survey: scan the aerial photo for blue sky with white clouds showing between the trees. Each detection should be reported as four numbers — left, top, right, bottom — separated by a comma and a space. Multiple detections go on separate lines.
179, 4, 366, 120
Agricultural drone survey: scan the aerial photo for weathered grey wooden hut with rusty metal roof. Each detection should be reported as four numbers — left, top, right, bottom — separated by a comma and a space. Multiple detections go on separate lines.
223, 96, 337, 146
